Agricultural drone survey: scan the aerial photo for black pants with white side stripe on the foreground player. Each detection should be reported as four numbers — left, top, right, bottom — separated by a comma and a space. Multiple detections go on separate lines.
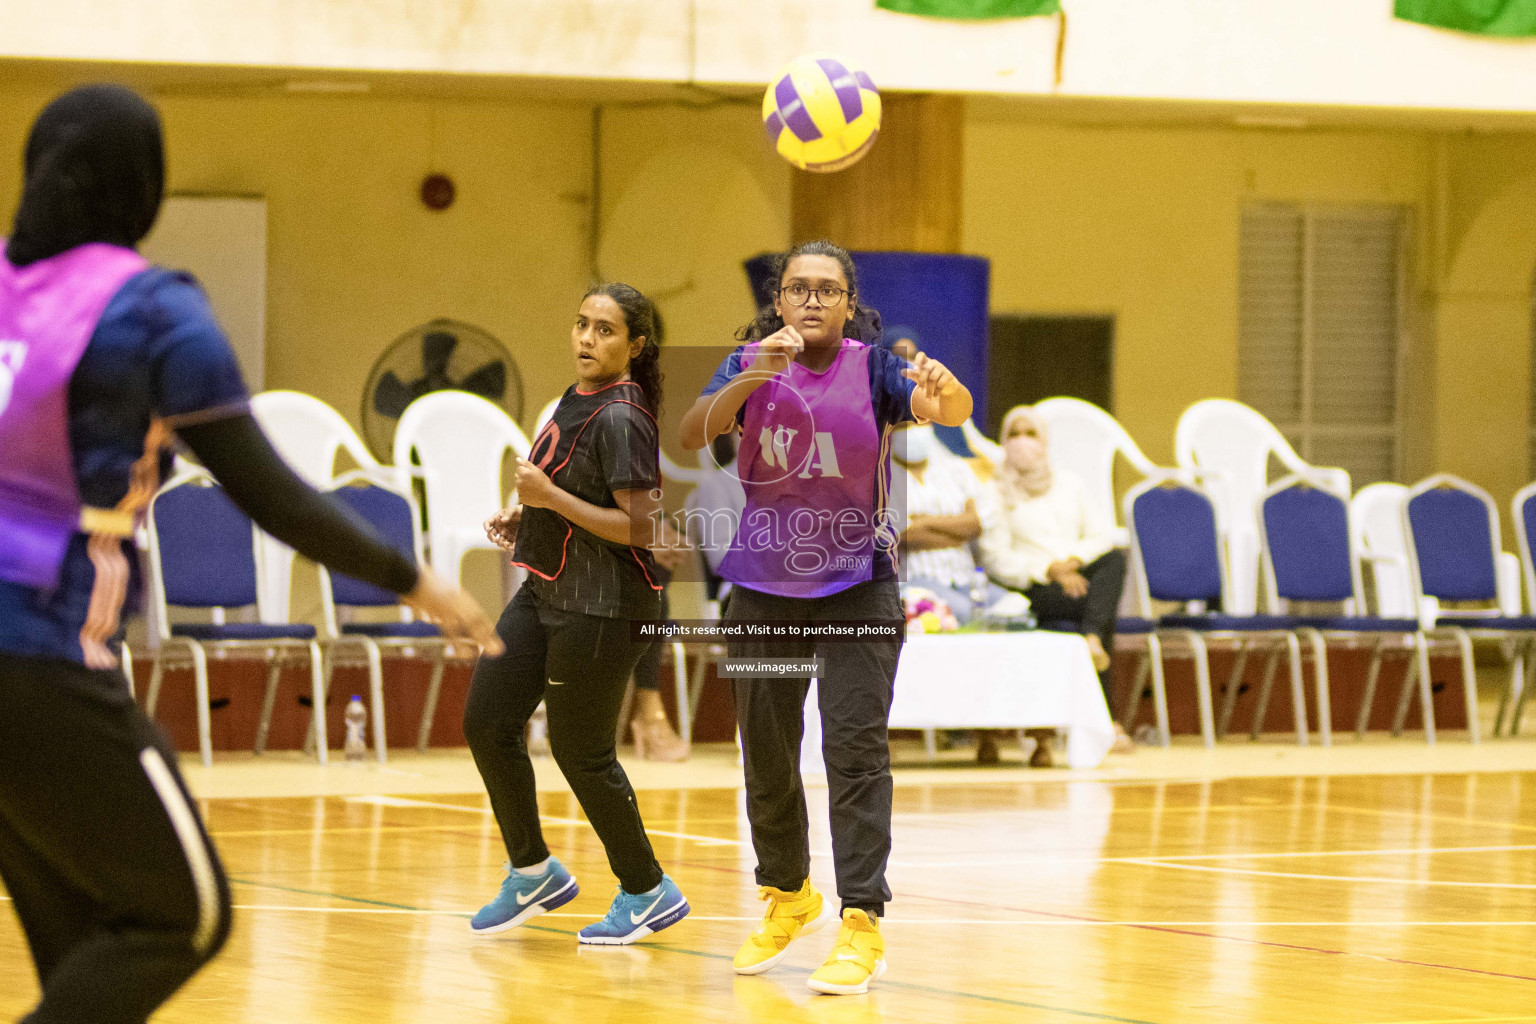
0, 654, 229, 1024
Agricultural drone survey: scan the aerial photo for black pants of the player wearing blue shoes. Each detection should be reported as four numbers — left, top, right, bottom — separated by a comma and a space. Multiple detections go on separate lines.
464, 586, 662, 894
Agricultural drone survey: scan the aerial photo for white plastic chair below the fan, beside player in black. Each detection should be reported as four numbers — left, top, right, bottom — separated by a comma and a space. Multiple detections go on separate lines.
395, 391, 530, 582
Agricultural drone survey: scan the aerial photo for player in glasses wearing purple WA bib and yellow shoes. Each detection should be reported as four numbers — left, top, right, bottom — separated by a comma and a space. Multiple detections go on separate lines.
682, 241, 971, 995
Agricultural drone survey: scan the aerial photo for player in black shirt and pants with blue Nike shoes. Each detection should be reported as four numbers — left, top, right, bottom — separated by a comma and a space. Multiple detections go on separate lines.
464, 284, 688, 946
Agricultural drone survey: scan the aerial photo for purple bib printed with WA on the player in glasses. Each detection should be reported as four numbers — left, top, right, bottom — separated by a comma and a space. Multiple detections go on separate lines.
720, 338, 894, 597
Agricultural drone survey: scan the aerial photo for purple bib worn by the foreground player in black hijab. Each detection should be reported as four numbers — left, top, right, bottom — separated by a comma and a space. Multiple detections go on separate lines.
0, 243, 149, 590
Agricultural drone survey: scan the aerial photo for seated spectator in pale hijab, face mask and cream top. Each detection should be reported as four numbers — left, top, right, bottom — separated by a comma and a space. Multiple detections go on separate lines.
980, 405, 1129, 748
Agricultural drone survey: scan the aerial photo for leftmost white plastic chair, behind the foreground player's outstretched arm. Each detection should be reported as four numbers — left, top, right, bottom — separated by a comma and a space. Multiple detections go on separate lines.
250, 391, 378, 622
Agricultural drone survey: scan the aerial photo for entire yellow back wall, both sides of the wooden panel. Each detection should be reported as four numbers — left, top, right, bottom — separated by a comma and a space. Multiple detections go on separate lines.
9, 78, 1536, 528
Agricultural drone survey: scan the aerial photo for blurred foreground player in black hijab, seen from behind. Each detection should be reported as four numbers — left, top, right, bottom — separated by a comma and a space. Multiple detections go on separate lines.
0, 86, 499, 1024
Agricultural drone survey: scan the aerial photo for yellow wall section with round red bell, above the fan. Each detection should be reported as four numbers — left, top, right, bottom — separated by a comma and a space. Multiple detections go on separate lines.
0, 83, 590, 442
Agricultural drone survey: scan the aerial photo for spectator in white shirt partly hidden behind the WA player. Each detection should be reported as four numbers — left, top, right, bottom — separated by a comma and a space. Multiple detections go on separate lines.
891, 424, 1008, 622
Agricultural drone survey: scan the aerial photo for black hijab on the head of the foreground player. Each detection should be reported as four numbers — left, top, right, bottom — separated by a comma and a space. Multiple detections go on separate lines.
5, 86, 166, 267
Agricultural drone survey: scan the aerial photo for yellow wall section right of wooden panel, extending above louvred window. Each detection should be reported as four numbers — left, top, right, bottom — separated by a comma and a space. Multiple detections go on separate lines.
965, 115, 1428, 464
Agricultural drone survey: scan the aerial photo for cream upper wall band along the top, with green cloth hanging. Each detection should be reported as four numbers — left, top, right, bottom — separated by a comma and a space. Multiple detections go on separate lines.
14, 0, 1536, 121
